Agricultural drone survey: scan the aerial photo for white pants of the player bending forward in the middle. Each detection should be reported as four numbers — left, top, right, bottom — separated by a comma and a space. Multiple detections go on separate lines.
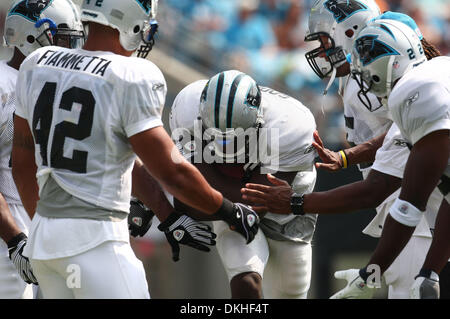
213, 221, 312, 299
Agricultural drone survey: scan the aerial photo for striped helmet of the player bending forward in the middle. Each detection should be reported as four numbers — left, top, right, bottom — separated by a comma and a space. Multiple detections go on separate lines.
200, 70, 263, 163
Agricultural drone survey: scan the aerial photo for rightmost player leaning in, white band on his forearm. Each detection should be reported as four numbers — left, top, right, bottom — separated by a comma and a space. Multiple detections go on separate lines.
352, 20, 450, 298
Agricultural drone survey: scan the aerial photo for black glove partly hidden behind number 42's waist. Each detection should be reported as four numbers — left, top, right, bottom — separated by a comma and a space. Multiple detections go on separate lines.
128, 199, 155, 237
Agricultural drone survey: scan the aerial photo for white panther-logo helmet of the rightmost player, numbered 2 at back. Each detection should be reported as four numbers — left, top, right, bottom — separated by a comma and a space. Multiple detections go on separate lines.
351, 19, 427, 111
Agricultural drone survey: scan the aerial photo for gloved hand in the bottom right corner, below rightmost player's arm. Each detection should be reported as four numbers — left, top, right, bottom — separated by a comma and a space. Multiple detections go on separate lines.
410, 269, 440, 299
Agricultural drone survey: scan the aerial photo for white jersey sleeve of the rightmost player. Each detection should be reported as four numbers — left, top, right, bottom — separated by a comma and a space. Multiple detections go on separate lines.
389, 82, 450, 145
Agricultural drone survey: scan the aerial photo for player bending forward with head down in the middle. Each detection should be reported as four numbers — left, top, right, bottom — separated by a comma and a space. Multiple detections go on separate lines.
163, 70, 316, 298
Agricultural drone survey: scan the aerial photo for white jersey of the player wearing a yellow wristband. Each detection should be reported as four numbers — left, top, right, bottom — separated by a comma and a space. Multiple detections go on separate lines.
342, 76, 392, 170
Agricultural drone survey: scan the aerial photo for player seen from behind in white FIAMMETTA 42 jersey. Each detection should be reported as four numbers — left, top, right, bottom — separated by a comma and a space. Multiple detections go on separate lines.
12, 0, 259, 298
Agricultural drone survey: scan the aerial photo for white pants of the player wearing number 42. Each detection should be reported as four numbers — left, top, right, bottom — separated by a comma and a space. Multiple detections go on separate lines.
31, 241, 150, 299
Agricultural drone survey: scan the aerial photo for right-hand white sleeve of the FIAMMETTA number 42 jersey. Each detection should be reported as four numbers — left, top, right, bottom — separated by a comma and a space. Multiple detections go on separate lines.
121, 66, 167, 137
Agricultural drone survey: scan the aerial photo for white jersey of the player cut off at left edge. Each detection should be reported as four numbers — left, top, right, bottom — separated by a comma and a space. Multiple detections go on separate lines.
0, 61, 22, 205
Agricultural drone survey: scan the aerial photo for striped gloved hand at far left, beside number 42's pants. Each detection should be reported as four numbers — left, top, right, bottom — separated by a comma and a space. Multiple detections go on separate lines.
7, 233, 38, 285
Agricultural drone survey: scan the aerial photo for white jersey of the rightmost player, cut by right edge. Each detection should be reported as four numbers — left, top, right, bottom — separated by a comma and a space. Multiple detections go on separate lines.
388, 57, 450, 182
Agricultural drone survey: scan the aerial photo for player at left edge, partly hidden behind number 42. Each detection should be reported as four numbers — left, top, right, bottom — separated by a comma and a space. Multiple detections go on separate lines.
0, 0, 84, 298
